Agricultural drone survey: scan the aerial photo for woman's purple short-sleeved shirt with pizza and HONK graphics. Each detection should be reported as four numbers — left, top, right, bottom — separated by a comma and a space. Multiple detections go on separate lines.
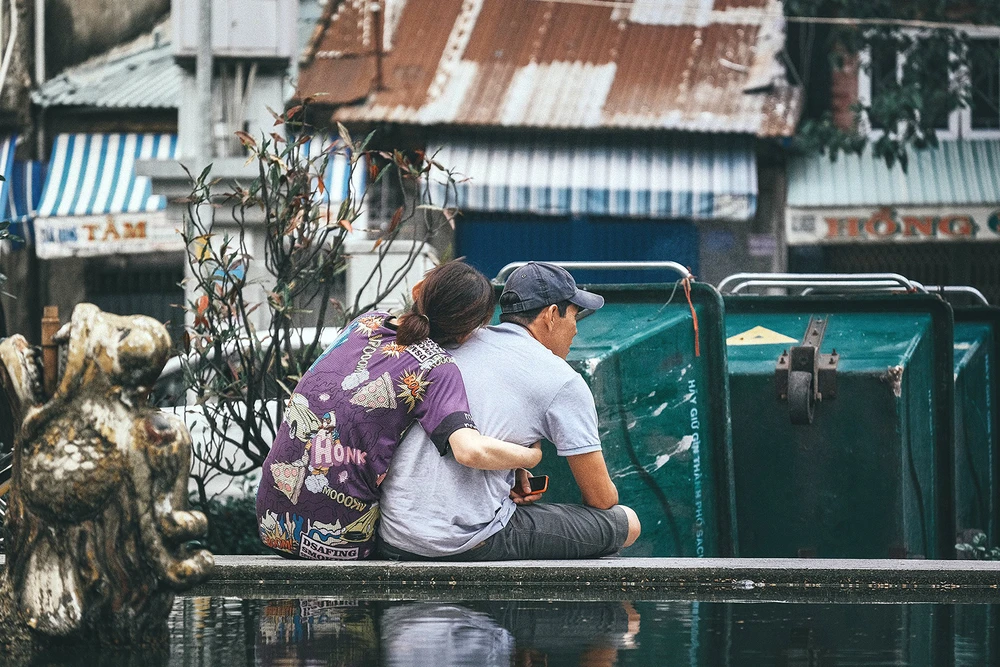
257, 312, 476, 560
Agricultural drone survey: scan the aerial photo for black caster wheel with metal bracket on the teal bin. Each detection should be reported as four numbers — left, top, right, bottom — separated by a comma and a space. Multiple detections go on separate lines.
774, 315, 840, 425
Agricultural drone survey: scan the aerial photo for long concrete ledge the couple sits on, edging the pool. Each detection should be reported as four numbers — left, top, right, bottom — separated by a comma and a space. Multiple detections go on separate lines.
192, 556, 1000, 603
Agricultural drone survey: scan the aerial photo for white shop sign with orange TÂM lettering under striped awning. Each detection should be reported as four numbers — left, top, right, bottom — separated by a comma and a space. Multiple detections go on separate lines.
35, 211, 184, 259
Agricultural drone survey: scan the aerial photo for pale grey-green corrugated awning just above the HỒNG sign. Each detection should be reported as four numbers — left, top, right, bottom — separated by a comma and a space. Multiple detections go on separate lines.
788, 139, 1000, 208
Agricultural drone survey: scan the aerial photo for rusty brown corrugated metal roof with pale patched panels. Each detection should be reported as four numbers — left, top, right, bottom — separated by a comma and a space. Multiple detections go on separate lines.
299, 0, 801, 136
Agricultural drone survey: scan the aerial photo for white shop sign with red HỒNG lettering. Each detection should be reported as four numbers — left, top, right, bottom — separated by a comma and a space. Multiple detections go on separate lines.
785, 205, 1000, 245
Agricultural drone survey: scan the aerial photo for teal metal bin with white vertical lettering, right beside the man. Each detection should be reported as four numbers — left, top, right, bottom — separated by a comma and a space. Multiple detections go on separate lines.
533, 283, 737, 557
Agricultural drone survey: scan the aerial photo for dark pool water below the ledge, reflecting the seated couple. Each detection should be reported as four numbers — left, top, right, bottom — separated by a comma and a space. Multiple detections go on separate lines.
160, 598, 1000, 667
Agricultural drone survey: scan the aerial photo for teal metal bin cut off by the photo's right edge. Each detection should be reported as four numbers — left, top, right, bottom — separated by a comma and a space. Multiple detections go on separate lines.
954, 307, 1000, 543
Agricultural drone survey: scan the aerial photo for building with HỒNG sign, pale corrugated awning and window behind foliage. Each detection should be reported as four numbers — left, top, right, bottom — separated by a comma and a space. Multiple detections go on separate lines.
785, 28, 1000, 303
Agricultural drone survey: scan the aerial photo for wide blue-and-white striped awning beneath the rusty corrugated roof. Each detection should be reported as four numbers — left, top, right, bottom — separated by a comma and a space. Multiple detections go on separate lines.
427, 134, 757, 220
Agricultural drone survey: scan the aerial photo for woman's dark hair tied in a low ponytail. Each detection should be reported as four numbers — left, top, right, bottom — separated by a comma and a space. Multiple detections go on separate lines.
396, 260, 496, 345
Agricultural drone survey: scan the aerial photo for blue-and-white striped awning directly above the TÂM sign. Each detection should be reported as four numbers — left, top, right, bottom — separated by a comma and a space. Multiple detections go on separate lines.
38, 133, 177, 218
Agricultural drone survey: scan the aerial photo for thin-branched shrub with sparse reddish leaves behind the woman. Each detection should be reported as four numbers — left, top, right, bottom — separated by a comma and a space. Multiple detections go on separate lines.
181, 107, 455, 506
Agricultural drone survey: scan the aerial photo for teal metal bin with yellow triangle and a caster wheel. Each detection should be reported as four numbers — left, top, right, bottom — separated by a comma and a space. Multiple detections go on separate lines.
725, 294, 955, 558
